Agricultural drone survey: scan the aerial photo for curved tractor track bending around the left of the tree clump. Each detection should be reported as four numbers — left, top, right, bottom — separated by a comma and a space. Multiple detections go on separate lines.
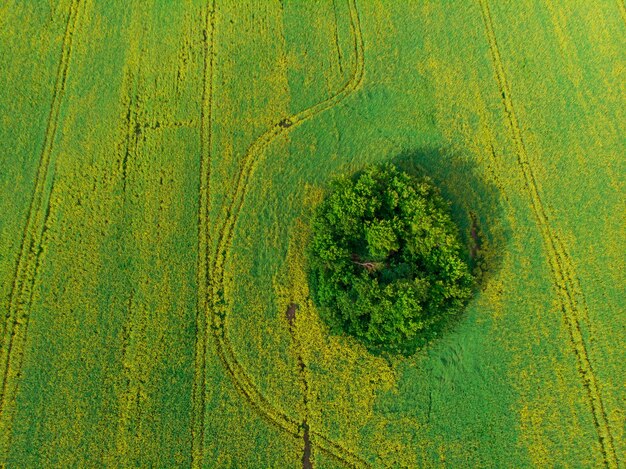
194, 0, 369, 467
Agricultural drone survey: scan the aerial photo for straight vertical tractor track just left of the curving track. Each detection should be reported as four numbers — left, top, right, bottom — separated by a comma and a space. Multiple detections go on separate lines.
191, 0, 215, 467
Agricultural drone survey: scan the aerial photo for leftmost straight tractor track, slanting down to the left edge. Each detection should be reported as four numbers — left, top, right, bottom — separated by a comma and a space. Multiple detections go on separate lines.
0, 0, 82, 456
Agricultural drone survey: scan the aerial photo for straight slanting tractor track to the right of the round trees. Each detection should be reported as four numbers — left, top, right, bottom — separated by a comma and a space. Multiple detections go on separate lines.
479, 0, 618, 468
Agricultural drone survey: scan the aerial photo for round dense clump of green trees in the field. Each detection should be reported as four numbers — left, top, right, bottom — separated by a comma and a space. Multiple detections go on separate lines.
309, 164, 474, 353
